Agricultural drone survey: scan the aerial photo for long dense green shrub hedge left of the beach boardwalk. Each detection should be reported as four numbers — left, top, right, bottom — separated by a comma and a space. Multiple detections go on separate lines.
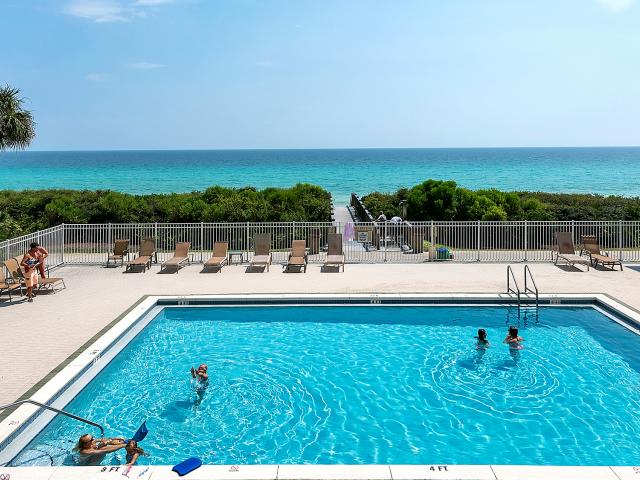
0, 184, 331, 240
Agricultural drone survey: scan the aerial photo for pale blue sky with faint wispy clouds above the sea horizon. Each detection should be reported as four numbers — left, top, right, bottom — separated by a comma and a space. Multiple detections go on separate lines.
0, 0, 640, 150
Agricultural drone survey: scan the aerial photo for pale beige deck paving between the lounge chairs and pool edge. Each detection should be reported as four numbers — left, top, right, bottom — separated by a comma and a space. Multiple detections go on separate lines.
0, 263, 640, 403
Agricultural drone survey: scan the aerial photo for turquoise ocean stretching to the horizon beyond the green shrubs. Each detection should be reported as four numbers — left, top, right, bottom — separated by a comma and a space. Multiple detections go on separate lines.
0, 147, 640, 205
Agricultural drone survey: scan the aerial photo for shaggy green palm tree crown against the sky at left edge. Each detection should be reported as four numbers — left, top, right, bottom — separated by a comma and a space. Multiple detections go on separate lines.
0, 85, 36, 151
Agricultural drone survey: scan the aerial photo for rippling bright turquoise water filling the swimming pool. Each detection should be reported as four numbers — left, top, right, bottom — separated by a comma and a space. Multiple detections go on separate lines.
8, 306, 640, 465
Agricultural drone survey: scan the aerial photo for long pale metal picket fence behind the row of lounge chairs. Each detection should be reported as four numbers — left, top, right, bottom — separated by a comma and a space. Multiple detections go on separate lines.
0, 221, 640, 267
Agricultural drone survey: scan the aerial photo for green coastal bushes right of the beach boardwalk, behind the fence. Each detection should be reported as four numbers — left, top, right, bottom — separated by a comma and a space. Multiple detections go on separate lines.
362, 180, 640, 221
